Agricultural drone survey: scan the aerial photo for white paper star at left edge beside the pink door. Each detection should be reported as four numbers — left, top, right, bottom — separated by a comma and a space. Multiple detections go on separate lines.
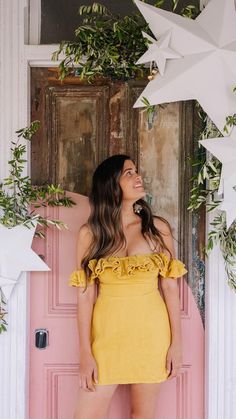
0, 225, 50, 300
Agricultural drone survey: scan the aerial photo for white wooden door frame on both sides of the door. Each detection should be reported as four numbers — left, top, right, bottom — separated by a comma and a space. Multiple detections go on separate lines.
0, 0, 236, 419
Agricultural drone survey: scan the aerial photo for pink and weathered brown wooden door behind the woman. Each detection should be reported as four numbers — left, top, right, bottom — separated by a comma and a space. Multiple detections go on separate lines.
29, 69, 204, 419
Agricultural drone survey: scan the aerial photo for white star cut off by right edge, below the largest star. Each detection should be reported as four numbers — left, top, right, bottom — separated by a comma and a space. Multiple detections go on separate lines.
199, 128, 236, 228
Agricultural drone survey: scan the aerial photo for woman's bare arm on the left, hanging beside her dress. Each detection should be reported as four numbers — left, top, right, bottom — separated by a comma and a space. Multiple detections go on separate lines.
77, 225, 97, 391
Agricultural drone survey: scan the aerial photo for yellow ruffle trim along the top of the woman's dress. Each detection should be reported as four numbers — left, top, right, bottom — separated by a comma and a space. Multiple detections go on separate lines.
88, 253, 188, 280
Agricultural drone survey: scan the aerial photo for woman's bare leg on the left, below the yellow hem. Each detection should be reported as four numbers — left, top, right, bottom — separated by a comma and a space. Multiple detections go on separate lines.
74, 384, 118, 419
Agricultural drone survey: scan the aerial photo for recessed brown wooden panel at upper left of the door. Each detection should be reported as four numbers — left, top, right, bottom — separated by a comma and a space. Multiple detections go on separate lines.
46, 86, 109, 195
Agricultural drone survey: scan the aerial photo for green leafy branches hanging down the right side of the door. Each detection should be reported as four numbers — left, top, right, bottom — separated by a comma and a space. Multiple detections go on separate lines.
188, 105, 236, 290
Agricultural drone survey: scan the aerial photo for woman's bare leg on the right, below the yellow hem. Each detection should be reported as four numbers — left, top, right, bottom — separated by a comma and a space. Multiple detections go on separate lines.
131, 383, 160, 419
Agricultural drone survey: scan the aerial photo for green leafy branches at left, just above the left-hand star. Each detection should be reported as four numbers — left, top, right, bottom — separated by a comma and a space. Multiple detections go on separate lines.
0, 121, 73, 236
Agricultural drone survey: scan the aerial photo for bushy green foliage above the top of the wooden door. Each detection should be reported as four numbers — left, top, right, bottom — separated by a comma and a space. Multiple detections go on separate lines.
52, 0, 199, 82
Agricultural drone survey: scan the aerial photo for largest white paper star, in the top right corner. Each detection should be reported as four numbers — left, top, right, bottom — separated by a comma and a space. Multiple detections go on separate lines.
134, 0, 236, 133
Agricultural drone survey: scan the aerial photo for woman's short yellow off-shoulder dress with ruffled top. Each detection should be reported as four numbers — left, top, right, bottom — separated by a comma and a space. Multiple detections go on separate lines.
69, 253, 187, 385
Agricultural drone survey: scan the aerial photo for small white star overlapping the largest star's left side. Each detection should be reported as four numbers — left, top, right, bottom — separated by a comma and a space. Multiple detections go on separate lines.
137, 30, 181, 76
